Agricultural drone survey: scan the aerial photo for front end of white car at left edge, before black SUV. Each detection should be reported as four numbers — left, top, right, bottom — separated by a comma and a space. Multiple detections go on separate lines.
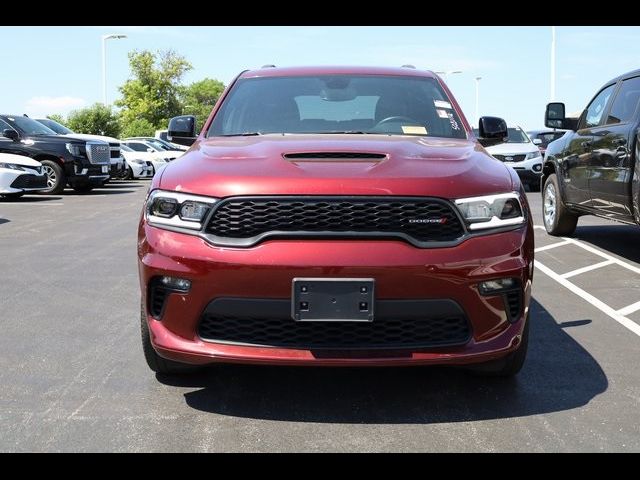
0, 153, 47, 198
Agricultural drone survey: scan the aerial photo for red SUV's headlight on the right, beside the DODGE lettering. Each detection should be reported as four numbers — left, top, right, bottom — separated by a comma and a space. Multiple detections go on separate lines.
456, 192, 524, 230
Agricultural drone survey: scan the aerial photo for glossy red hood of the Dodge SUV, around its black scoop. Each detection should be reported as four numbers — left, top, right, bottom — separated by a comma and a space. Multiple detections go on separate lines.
159, 135, 513, 198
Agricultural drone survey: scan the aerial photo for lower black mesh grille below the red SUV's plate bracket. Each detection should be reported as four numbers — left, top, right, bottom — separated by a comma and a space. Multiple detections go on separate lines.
198, 313, 471, 349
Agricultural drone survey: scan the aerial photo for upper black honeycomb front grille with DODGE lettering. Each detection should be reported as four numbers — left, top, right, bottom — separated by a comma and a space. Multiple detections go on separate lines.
206, 197, 464, 246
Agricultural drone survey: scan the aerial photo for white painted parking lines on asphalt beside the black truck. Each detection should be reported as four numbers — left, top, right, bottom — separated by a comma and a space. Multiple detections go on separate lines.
533, 225, 640, 337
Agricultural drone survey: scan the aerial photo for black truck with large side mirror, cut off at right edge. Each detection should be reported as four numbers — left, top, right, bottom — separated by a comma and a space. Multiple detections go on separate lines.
542, 70, 640, 235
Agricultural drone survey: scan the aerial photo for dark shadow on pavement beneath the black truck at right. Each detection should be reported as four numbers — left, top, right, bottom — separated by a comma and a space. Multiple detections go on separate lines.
574, 224, 640, 263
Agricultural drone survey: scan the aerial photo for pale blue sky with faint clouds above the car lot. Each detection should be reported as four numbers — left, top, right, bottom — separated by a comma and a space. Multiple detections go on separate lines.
0, 26, 640, 130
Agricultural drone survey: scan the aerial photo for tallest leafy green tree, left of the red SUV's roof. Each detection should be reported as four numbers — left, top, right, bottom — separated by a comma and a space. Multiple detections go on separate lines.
115, 50, 193, 129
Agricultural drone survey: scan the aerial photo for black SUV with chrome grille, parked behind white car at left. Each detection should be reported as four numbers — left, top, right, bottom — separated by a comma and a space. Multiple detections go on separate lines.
0, 115, 111, 193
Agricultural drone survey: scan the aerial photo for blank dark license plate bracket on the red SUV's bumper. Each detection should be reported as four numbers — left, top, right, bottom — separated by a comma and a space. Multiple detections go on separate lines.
291, 278, 375, 322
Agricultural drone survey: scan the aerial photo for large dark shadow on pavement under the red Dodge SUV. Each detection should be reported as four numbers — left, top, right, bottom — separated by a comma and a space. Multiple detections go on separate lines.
157, 300, 608, 424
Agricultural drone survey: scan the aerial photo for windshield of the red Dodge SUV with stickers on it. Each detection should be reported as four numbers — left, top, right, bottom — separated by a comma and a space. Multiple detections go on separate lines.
207, 75, 466, 138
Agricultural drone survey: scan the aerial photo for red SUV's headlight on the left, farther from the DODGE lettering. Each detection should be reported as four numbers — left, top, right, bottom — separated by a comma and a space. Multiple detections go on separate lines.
145, 190, 218, 230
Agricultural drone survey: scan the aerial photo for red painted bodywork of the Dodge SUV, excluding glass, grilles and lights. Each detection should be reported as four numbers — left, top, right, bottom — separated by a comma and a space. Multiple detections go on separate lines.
138, 67, 534, 366
